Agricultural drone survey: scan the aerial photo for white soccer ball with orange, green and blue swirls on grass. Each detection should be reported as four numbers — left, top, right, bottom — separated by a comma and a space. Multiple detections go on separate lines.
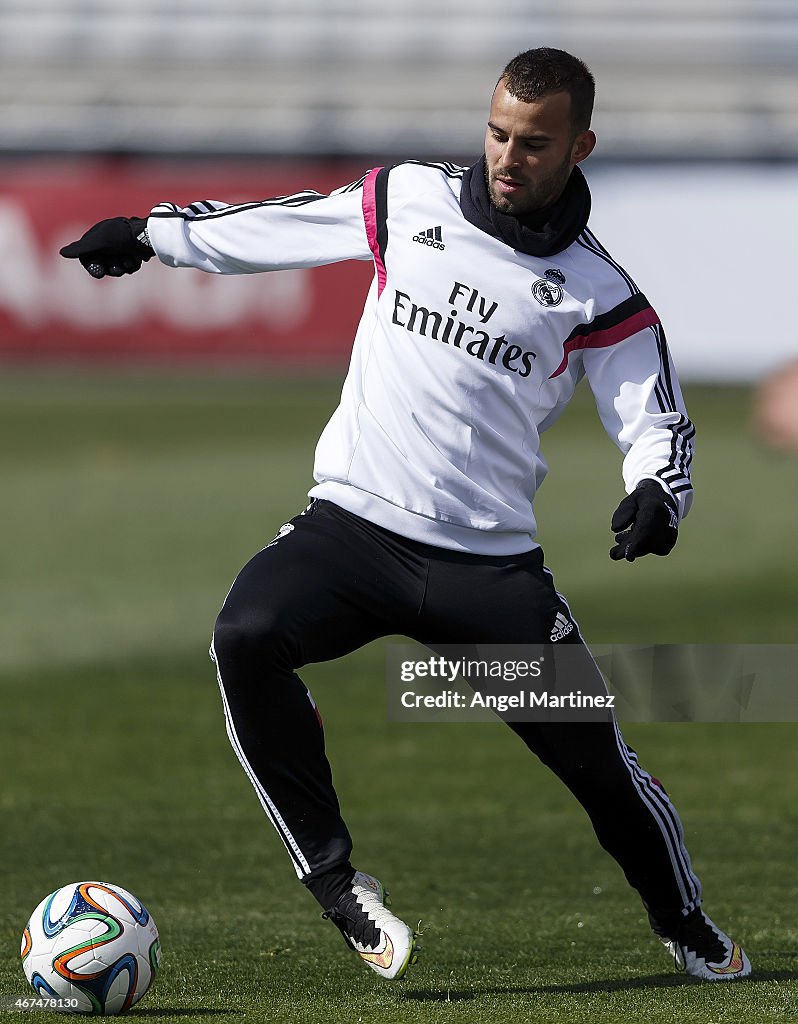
20, 882, 161, 1016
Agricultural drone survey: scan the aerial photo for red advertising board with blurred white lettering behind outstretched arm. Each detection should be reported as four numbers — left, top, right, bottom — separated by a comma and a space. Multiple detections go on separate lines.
0, 158, 373, 362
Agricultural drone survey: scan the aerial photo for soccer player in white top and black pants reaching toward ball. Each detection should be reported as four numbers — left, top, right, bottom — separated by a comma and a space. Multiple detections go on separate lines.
61, 48, 751, 981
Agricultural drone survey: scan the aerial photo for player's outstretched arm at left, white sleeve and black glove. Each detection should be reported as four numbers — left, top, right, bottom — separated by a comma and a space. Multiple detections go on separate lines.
61, 181, 372, 276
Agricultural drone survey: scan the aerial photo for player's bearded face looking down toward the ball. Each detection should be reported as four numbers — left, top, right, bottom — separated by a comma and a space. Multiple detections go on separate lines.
485, 82, 595, 217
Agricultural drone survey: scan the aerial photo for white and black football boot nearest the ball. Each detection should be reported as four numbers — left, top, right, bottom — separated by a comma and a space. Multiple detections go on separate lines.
322, 871, 419, 980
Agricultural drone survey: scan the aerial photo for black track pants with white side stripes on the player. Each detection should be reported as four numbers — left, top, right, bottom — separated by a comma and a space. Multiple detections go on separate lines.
212, 501, 701, 921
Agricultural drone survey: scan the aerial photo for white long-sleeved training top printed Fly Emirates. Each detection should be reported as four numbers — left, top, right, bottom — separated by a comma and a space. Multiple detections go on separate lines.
148, 161, 694, 554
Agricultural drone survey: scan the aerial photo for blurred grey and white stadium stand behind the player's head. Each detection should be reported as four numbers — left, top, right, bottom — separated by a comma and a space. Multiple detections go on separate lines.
0, 0, 798, 159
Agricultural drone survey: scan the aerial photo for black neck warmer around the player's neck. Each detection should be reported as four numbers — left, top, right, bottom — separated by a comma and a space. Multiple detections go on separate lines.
460, 157, 590, 256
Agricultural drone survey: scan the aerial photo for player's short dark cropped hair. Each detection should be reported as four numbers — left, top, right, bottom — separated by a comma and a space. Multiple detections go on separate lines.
497, 46, 596, 133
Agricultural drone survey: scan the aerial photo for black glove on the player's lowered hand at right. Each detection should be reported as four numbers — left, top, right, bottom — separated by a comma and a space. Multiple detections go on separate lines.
610, 480, 679, 562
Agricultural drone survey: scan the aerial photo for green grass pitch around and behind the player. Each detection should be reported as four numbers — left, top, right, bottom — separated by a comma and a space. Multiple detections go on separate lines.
0, 372, 798, 1024
